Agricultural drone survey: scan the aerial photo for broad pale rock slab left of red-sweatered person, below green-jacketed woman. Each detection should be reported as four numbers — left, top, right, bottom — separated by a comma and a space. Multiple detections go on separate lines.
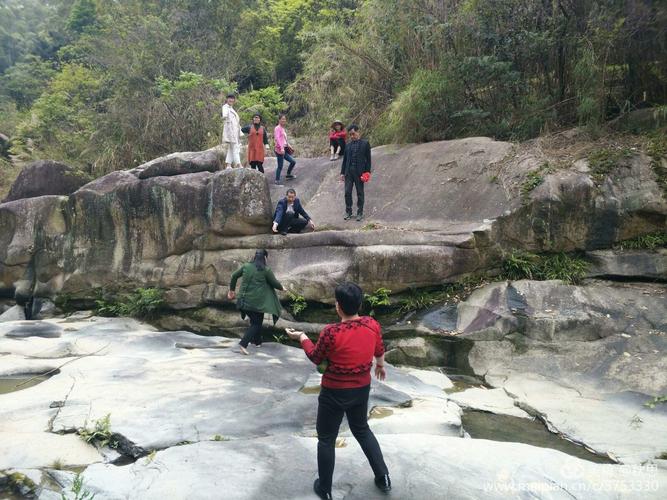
0, 317, 444, 467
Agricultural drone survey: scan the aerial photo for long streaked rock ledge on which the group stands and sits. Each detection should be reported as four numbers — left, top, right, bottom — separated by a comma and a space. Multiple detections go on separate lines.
0, 138, 667, 309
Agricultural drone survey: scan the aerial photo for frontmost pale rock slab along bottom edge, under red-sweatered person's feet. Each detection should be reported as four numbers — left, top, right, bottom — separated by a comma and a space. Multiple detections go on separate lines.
40, 434, 667, 500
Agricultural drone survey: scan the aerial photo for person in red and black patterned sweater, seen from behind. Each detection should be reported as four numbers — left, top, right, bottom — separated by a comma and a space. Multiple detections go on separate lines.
287, 283, 391, 499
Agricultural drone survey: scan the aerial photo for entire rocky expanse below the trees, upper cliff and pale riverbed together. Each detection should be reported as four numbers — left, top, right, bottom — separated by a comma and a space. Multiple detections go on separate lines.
0, 131, 667, 499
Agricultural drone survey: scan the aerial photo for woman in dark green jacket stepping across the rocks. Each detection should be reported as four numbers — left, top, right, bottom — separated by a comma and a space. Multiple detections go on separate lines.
227, 250, 283, 354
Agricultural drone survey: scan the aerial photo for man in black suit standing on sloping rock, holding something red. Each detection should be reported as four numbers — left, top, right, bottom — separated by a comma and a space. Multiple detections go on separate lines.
340, 124, 371, 221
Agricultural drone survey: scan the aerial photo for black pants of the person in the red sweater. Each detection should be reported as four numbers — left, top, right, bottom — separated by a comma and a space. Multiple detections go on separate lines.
317, 385, 389, 492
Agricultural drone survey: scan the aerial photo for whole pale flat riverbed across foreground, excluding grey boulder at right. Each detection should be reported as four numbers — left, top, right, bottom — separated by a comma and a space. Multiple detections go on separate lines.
0, 314, 667, 499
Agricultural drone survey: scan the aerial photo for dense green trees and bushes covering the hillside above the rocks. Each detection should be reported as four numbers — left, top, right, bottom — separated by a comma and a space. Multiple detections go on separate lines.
0, 0, 667, 174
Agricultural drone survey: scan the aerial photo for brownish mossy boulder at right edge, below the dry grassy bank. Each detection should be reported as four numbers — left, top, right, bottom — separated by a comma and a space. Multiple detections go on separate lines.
495, 147, 667, 251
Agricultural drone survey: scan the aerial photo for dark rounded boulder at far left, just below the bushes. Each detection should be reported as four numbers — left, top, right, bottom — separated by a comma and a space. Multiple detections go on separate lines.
4, 160, 90, 202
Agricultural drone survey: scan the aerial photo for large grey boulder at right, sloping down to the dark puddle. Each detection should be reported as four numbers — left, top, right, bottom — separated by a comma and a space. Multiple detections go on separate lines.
454, 281, 667, 463
